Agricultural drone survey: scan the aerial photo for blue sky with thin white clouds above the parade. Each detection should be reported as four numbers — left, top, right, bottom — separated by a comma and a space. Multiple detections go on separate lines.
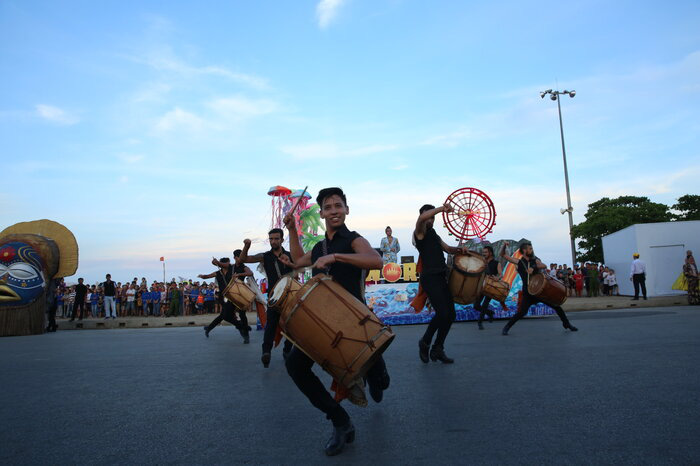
0, 0, 700, 282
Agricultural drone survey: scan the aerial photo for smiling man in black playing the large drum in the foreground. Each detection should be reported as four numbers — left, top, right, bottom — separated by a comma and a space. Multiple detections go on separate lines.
284, 188, 389, 456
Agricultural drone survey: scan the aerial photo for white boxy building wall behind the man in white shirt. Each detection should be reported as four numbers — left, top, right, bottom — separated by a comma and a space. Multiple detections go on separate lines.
603, 220, 700, 296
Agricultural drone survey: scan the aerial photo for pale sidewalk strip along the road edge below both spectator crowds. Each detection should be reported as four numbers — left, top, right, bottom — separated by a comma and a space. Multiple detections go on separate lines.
56, 295, 688, 330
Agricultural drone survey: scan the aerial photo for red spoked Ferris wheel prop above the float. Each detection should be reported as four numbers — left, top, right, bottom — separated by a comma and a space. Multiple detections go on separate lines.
442, 188, 496, 240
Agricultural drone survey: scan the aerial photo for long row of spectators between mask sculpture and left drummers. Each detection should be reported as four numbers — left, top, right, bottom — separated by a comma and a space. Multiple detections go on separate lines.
56, 278, 232, 320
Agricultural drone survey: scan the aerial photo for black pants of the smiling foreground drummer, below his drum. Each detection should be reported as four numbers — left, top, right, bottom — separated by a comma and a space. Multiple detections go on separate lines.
286, 347, 386, 427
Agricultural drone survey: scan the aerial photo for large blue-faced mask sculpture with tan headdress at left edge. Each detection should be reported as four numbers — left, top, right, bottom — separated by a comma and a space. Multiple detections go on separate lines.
0, 220, 78, 336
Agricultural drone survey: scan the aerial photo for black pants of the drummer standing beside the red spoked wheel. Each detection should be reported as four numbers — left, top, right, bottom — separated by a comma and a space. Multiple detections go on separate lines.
420, 273, 456, 348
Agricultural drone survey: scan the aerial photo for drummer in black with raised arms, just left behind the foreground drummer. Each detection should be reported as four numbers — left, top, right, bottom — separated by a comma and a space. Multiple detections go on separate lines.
241, 228, 294, 367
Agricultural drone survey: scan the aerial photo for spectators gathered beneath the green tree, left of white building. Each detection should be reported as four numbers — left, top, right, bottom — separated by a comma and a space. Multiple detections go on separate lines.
546, 262, 620, 298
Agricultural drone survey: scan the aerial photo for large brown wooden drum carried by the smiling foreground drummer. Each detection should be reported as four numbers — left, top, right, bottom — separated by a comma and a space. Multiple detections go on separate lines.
280, 274, 394, 388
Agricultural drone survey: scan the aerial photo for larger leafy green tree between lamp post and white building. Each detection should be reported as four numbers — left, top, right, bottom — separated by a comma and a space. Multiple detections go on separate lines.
573, 196, 673, 262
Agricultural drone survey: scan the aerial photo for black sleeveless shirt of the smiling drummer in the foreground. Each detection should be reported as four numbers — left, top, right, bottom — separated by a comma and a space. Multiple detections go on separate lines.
311, 225, 365, 303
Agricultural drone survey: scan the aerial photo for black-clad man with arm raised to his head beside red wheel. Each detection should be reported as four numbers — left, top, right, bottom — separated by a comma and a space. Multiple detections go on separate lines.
413, 204, 467, 364
